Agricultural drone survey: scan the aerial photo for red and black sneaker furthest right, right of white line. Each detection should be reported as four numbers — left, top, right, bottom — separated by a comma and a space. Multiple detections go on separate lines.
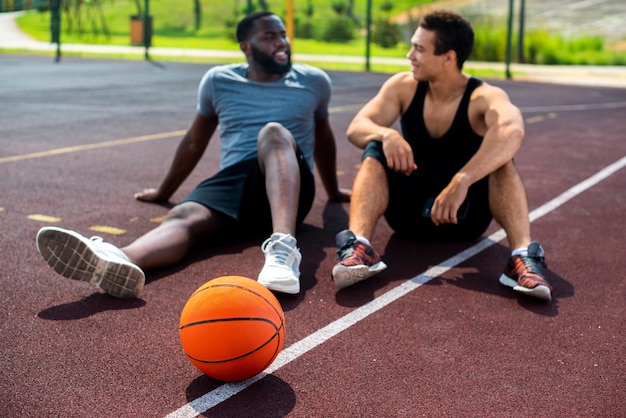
500, 241, 552, 301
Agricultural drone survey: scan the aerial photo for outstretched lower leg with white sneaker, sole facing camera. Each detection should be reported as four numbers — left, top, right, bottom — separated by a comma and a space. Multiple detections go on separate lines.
37, 202, 220, 298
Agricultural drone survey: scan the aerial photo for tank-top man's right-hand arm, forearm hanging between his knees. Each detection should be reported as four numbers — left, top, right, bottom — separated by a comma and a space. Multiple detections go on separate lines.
431, 85, 524, 225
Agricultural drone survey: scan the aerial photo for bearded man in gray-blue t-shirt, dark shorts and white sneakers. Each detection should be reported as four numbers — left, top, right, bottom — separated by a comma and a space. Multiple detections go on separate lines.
37, 12, 350, 298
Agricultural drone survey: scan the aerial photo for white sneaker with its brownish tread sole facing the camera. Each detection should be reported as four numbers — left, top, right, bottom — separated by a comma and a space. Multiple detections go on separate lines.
37, 227, 145, 299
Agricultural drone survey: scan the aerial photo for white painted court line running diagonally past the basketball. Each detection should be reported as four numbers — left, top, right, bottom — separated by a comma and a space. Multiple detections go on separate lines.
166, 156, 626, 418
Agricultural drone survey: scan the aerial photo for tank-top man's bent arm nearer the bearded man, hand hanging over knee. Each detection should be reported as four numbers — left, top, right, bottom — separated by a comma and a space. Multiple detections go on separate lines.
346, 73, 417, 175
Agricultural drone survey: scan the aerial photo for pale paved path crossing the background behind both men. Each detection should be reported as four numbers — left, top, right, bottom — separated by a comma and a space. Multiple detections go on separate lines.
0, 12, 626, 88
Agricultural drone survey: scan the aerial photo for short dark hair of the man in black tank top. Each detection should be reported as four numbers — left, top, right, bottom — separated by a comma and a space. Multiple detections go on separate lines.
419, 10, 474, 70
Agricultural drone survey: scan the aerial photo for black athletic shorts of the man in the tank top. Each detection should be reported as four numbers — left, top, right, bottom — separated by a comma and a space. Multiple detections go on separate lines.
361, 141, 493, 241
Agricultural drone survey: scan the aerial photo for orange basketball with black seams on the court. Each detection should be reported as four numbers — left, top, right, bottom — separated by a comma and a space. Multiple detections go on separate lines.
179, 276, 285, 382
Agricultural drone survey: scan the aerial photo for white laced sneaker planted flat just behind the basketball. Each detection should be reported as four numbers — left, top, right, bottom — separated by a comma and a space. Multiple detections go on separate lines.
257, 232, 302, 295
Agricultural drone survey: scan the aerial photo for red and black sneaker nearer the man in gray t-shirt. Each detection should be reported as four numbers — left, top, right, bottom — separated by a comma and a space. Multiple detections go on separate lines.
332, 229, 387, 289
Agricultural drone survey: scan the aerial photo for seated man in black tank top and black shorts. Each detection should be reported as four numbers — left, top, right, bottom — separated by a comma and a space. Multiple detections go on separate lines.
332, 11, 552, 301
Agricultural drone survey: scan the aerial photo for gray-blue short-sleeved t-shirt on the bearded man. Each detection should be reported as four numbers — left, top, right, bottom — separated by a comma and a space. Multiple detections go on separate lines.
198, 63, 331, 170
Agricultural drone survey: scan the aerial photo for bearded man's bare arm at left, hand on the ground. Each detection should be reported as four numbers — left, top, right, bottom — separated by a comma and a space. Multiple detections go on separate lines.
135, 114, 218, 202
